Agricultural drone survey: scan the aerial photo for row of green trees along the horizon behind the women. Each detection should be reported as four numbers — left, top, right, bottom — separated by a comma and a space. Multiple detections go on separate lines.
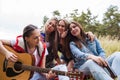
43, 5, 120, 40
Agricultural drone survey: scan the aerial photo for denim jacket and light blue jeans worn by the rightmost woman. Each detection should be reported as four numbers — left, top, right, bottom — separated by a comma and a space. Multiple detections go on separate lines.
70, 38, 120, 80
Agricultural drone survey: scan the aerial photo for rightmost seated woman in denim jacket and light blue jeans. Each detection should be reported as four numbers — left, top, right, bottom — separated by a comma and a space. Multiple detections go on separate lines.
68, 21, 120, 80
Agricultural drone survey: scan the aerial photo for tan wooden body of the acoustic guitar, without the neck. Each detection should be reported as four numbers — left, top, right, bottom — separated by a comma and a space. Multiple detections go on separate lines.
0, 46, 33, 80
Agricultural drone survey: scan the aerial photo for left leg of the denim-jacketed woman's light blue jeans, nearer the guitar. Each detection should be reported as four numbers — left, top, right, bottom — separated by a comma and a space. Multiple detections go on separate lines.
79, 60, 113, 80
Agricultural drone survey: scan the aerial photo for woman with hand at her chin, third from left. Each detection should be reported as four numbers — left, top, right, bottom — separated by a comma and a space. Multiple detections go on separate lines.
57, 19, 74, 71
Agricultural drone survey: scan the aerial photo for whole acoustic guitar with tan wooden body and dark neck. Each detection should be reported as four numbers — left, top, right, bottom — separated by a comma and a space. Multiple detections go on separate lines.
0, 46, 82, 80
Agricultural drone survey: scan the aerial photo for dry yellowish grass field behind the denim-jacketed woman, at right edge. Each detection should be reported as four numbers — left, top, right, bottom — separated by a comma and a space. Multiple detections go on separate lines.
99, 37, 120, 56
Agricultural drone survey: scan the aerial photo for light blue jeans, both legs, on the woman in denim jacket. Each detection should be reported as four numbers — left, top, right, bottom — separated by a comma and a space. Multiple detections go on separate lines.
79, 52, 120, 80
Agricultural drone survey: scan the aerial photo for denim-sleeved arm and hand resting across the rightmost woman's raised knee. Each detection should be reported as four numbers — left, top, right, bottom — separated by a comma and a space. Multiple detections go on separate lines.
70, 42, 107, 66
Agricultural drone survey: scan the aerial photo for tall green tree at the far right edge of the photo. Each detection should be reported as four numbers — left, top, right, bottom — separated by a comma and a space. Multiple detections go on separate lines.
103, 5, 120, 39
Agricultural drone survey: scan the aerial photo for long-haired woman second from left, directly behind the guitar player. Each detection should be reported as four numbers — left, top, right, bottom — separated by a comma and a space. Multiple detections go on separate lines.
41, 18, 69, 80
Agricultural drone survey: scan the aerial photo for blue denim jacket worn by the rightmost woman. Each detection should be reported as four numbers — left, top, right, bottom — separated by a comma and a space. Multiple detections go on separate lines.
70, 38, 105, 68
